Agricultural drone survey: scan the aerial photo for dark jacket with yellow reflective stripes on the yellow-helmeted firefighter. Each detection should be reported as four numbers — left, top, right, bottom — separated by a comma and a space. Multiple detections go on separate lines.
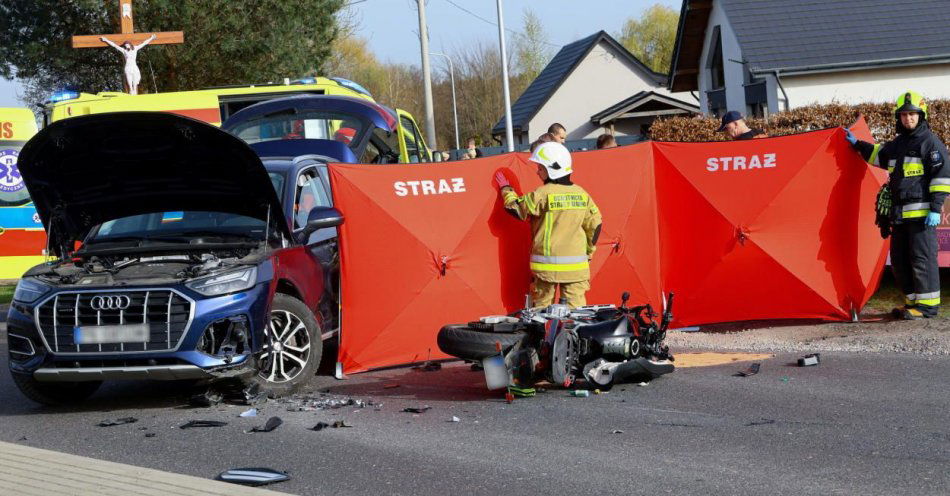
854, 119, 950, 222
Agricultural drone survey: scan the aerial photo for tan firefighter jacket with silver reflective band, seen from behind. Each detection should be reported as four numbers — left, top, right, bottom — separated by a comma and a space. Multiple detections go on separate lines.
502, 183, 601, 283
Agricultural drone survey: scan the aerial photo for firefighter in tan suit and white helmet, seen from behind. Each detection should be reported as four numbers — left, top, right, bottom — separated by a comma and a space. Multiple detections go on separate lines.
495, 142, 601, 307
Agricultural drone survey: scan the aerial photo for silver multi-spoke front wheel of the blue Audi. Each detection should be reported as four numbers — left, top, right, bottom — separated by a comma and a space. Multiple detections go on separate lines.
259, 310, 310, 383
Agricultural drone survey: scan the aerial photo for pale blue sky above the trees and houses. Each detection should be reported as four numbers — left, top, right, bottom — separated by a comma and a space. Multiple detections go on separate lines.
0, 0, 681, 107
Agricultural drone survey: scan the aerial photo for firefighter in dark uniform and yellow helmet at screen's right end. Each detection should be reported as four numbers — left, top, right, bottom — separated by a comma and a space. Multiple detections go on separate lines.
845, 91, 950, 320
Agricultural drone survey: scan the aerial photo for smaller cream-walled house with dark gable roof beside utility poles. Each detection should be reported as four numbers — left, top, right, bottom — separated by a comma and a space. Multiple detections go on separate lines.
492, 31, 699, 146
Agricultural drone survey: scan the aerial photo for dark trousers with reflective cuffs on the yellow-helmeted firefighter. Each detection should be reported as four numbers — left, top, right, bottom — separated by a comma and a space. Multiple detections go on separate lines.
891, 221, 940, 317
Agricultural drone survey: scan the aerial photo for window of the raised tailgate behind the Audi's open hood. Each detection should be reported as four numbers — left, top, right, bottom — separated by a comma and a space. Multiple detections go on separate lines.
231, 111, 369, 149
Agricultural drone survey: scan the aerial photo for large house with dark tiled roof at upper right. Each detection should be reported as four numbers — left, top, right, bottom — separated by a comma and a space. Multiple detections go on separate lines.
668, 0, 950, 116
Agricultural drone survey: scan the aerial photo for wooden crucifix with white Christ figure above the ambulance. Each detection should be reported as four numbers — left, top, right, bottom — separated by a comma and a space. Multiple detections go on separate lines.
73, 0, 185, 95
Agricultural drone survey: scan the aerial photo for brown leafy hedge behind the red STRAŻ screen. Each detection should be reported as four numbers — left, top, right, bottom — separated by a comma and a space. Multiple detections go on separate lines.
650, 100, 950, 143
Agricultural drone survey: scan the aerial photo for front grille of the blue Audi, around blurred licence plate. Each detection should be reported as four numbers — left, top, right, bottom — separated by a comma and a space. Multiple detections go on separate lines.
36, 289, 194, 354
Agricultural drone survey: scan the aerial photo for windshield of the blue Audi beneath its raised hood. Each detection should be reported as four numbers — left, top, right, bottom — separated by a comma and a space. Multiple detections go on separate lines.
86, 211, 265, 243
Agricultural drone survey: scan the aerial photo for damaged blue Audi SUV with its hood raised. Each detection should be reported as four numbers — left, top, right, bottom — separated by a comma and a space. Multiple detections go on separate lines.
7, 112, 343, 405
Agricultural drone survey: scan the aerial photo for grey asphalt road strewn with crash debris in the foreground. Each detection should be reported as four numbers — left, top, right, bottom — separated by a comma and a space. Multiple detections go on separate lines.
0, 353, 950, 496
